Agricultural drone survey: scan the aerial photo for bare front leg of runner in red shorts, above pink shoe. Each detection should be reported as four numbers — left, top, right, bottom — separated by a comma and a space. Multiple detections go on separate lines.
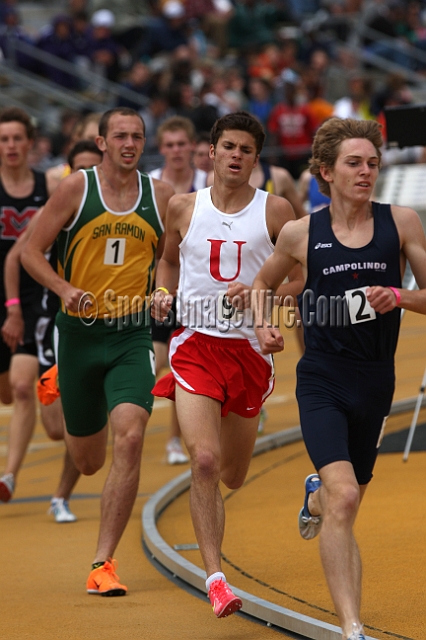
176, 385, 225, 576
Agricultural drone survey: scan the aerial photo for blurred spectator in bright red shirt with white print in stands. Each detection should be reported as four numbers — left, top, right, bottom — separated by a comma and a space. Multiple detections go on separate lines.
268, 69, 315, 180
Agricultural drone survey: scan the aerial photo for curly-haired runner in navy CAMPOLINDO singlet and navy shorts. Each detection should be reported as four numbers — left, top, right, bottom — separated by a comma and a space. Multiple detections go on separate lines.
253, 118, 426, 640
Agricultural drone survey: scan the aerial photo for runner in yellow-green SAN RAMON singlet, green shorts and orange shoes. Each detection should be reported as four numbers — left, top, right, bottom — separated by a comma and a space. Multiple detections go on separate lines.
22, 108, 174, 596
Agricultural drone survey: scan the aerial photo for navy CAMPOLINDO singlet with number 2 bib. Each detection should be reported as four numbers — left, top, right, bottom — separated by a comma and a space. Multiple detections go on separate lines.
298, 202, 401, 362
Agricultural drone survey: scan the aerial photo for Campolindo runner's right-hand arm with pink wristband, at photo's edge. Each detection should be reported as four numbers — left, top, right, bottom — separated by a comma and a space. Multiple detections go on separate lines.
367, 206, 426, 314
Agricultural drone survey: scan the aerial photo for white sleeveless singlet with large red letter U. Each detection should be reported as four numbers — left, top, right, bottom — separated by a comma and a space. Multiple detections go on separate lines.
177, 187, 274, 348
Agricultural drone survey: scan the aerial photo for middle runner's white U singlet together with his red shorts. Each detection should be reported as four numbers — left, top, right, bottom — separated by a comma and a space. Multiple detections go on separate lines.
153, 187, 274, 418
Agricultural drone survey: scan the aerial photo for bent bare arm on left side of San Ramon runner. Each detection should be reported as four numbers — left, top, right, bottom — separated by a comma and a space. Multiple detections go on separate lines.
21, 172, 85, 312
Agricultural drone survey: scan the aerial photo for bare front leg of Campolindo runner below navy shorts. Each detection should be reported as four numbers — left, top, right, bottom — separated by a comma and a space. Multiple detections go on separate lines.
308, 461, 367, 639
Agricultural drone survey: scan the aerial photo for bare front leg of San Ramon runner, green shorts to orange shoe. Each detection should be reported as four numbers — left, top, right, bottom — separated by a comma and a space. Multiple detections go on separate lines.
93, 403, 149, 562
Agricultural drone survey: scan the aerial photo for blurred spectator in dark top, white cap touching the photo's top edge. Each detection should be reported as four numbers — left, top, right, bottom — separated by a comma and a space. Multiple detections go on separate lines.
136, 0, 188, 60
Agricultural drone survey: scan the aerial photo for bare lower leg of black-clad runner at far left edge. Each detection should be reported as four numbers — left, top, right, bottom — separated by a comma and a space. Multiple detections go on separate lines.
5, 354, 38, 479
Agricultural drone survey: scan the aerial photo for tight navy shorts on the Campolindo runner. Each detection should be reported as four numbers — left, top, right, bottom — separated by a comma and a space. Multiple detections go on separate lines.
296, 352, 395, 485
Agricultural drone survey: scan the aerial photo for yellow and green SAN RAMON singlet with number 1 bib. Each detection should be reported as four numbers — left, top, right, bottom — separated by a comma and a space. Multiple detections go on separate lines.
58, 167, 164, 318
